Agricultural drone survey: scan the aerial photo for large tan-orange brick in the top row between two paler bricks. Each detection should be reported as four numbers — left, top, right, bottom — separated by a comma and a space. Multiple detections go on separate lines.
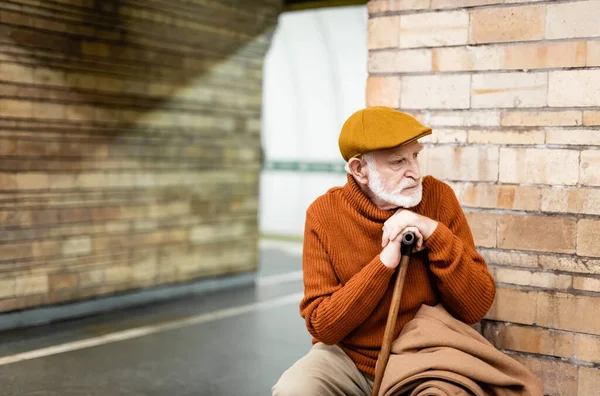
469, 6, 546, 44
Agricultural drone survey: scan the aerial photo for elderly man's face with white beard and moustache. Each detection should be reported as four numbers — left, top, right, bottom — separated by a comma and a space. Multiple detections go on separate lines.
367, 142, 423, 208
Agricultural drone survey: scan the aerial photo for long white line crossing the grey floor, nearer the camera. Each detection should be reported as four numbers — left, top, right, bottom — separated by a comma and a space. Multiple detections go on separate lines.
0, 293, 303, 366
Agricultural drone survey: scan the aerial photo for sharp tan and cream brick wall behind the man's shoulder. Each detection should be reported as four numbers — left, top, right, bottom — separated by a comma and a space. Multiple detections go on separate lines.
367, 0, 600, 396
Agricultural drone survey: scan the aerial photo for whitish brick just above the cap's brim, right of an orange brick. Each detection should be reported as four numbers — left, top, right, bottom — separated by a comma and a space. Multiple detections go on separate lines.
400, 75, 471, 109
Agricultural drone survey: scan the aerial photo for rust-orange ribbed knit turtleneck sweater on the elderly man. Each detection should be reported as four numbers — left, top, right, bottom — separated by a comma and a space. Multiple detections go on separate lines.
300, 175, 496, 376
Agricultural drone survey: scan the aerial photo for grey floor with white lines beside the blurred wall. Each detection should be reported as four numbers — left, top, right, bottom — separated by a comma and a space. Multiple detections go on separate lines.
0, 241, 311, 396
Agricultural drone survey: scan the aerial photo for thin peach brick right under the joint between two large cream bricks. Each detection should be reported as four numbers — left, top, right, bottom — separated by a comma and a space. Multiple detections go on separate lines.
500, 110, 582, 126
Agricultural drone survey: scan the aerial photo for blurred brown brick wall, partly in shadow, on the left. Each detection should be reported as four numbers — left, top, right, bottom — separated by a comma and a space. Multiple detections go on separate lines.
0, 0, 280, 311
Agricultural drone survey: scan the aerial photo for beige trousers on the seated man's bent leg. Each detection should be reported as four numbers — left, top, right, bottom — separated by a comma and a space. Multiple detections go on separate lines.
272, 343, 373, 396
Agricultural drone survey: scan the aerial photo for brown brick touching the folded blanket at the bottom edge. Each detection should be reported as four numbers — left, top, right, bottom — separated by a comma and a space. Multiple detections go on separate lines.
511, 355, 579, 396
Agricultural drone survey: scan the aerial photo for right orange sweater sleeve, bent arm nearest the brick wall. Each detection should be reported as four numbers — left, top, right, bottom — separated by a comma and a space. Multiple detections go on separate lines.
425, 186, 496, 324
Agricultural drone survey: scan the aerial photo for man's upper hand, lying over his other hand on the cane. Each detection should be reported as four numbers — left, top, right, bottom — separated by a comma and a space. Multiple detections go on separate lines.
381, 209, 438, 252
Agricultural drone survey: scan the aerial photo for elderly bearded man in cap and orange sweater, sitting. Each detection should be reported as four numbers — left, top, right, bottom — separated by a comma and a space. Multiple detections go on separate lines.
273, 107, 495, 396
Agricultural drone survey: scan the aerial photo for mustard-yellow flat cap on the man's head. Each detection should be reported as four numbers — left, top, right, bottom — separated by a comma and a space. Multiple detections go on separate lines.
338, 106, 431, 161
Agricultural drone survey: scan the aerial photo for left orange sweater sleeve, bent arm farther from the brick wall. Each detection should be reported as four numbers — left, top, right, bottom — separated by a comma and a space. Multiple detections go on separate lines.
300, 213, 394, 345
